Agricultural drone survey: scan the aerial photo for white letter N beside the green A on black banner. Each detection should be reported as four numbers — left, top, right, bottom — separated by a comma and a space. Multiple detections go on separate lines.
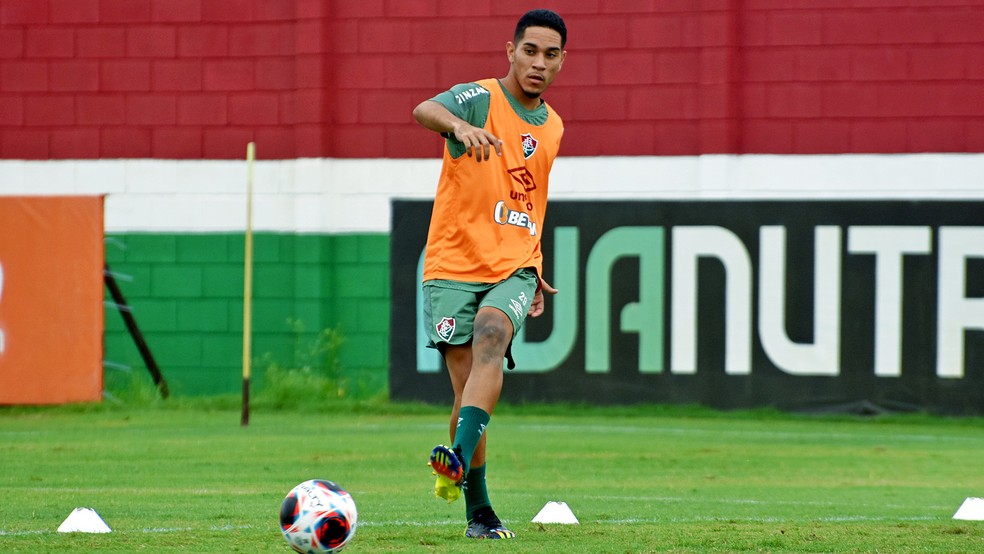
670, 226, 752, 375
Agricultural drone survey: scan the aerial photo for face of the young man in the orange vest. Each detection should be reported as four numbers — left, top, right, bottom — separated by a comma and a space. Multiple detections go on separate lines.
507, 27, 567, 99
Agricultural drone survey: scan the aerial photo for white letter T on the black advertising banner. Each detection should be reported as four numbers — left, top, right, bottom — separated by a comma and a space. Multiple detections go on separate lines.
847, 225, 933, 377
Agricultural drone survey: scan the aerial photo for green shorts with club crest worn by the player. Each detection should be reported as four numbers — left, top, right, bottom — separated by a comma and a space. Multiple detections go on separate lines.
423, 268, 539, 348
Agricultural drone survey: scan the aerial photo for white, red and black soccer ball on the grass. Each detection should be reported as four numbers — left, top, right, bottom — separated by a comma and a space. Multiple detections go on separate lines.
280, 479, 359, 554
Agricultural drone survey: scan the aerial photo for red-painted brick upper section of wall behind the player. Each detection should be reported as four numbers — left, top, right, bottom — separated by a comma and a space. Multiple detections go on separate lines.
0, 0, 984, 159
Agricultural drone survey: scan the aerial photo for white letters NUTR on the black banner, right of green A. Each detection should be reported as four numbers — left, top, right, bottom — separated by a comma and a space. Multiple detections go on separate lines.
668, 226, 984, 379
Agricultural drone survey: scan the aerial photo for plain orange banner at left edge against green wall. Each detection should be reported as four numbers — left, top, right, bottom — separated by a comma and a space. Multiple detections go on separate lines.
0, 196, 104, 404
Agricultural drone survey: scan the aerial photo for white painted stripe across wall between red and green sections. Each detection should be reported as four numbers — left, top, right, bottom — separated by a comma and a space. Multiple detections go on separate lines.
0, 154, 984, 233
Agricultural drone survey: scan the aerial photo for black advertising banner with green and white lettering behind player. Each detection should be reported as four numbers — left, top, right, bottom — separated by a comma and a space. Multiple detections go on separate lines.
390, 201, 984, 415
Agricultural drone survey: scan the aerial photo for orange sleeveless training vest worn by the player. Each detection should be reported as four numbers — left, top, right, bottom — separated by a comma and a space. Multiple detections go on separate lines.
424, 79, 564, 283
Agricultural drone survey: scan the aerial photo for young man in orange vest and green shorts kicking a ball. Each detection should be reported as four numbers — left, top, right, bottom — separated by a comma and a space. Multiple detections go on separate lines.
413, 6, 567, 539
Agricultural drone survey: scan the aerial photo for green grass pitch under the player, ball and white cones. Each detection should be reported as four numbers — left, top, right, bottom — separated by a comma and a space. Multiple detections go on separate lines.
0, 400, 984, 553
